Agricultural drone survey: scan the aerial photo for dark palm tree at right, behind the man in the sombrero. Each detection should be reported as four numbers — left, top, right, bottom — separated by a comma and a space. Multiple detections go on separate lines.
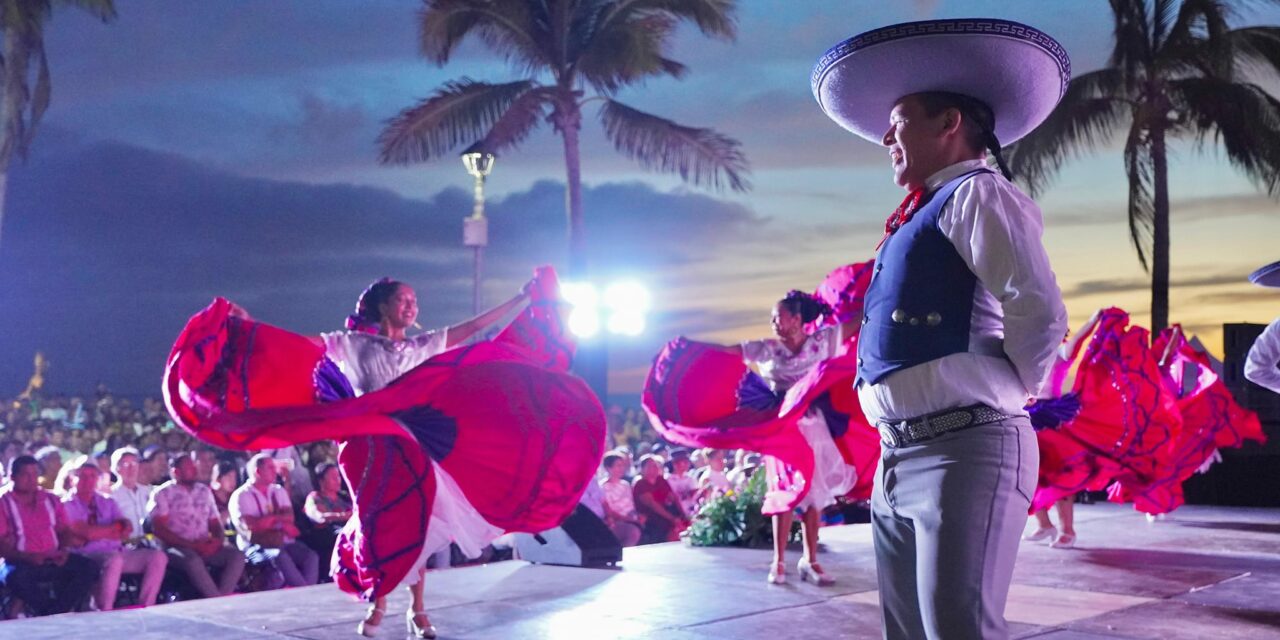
1010, 0, 1280, 335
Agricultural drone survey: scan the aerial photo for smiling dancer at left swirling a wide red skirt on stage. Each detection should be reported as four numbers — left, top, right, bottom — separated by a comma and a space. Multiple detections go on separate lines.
165, 269, 604, 637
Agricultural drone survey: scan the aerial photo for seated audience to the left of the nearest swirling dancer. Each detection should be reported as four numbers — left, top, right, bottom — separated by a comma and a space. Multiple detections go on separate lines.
0, 387, 352, 618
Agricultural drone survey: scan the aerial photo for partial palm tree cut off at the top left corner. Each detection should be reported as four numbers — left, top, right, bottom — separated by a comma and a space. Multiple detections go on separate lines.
0, 0, 115, 244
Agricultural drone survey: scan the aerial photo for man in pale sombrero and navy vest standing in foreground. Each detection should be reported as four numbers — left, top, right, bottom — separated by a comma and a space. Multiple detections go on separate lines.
813, 19, 1070, 640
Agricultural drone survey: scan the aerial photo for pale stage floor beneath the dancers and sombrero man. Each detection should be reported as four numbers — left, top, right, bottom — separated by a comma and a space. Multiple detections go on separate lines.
0, 504, 1280, 640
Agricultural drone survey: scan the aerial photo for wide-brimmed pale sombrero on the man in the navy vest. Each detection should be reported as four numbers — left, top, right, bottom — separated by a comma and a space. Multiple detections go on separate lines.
813, 18, 1071, 145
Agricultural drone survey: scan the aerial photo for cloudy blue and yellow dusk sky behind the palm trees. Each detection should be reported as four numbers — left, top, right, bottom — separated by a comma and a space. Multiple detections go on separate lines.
0, 0, 1280, 393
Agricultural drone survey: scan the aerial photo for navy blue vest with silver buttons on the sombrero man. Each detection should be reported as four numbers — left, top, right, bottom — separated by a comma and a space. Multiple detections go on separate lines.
858, 169, 993, 384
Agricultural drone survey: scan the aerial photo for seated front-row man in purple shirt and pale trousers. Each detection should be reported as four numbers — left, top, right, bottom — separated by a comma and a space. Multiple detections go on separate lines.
63, 462, 169, 611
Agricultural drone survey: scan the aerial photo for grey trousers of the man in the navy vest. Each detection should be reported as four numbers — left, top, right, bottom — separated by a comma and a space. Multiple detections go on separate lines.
872, 417, 1039, 640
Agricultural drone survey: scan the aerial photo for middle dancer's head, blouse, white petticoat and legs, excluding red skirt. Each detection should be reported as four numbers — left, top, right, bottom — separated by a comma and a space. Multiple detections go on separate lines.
696, 291, 858, 585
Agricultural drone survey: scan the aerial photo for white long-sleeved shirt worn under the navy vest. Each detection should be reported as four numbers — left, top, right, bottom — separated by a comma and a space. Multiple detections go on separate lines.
858, 160, 1068, 424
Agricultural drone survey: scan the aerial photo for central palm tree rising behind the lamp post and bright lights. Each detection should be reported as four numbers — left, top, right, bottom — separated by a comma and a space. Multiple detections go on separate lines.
378, 0, 749, 275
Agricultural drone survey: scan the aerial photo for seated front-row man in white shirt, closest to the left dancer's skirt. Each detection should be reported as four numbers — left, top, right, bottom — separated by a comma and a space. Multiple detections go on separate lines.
229, 452, 320, 586
